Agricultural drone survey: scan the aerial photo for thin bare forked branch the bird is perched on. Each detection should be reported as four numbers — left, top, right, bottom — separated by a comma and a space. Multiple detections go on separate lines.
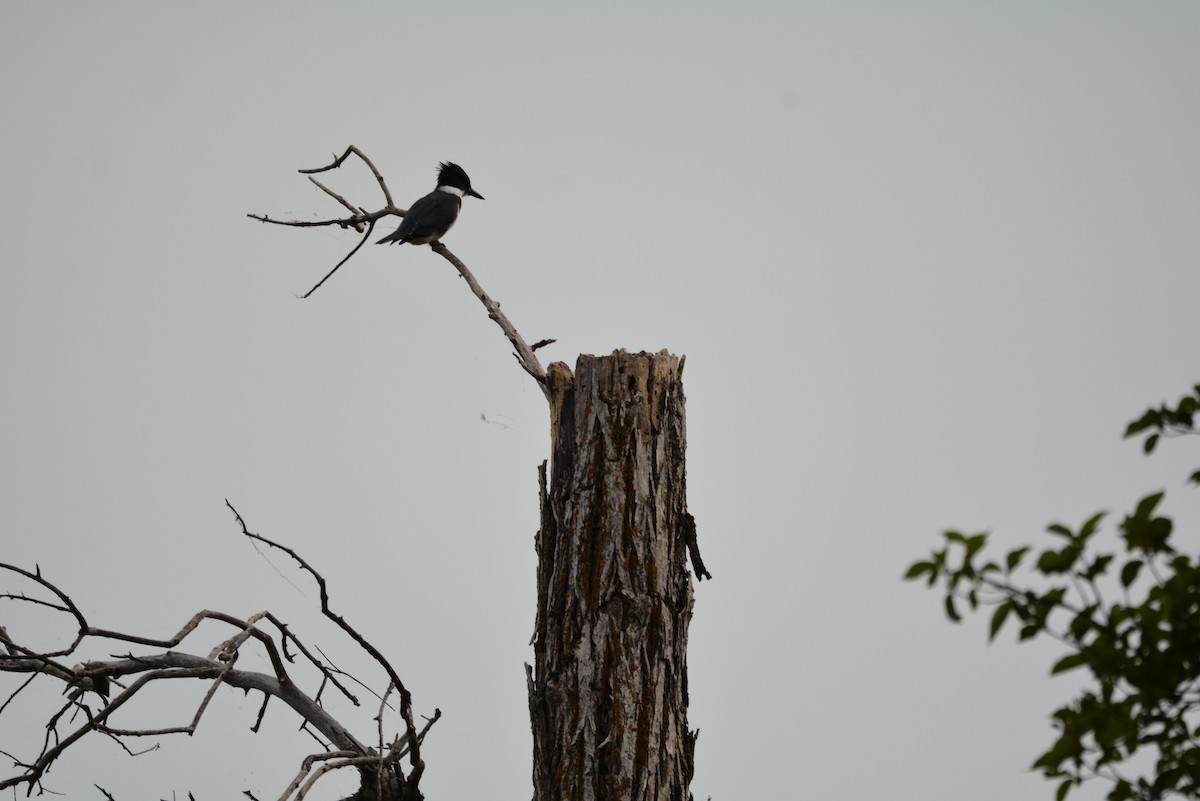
253, 145, 554, 398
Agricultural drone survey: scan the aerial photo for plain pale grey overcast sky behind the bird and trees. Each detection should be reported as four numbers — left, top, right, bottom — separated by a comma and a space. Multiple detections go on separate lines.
0, 1, 1200, 801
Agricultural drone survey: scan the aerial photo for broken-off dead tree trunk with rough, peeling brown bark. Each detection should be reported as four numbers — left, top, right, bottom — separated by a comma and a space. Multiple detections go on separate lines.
526, 350, 707, 801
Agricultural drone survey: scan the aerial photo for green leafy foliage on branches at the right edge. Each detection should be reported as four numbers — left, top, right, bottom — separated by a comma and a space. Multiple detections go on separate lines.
905, 385, 1200, 801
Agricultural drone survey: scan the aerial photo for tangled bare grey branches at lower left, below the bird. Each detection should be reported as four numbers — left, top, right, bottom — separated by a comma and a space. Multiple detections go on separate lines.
0, 501, 442, 801
